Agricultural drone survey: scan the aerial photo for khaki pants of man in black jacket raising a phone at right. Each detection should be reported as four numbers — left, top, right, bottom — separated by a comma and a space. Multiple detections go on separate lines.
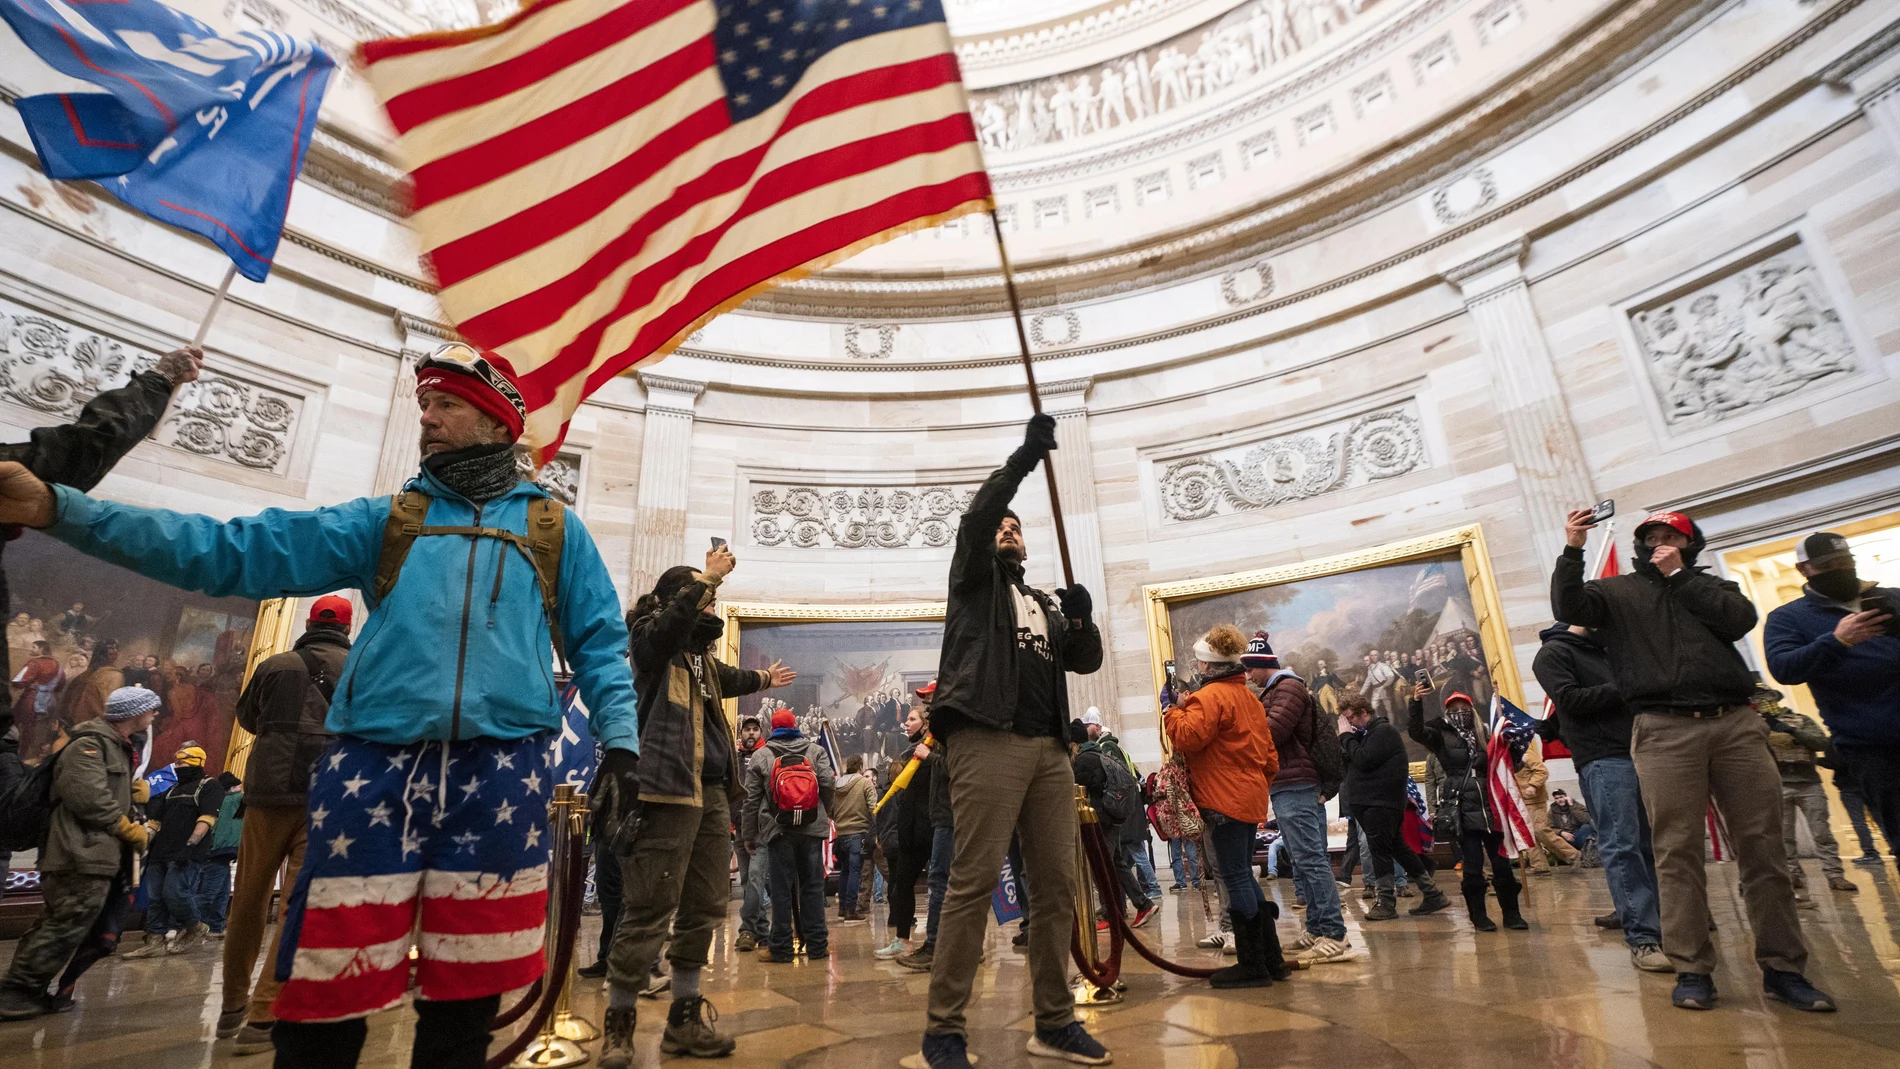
1630, 704, 1807, 972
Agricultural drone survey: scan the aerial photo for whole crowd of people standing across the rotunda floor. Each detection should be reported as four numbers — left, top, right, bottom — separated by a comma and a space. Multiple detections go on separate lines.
0, 358, 1900, 1069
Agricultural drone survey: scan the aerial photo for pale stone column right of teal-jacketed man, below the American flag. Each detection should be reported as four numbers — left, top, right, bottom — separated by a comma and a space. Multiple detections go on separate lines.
627, 372, 707, 604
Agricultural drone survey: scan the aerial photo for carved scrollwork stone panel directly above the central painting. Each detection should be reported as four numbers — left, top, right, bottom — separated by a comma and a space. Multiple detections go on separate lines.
749, 486, 975, 549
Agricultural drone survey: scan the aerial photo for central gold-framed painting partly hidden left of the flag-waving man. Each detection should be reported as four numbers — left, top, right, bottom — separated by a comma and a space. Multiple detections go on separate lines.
726, 606, 944, 767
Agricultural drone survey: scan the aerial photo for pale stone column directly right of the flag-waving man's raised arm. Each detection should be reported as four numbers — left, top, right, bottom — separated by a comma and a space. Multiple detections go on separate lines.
1041, 378, 1119, 729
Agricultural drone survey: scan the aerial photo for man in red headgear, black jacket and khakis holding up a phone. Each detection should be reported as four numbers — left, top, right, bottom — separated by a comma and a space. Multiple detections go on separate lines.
1550, 509, 1834, 1012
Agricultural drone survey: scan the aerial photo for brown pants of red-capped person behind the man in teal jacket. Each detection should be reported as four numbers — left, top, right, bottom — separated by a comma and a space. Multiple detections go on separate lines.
224, 805, 306, 1022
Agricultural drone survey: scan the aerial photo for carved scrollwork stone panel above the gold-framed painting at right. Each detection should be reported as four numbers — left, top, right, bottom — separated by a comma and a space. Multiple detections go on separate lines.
1155, 401, 1431, 522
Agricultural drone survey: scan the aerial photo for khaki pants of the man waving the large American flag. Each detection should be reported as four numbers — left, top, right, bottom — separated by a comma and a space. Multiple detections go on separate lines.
925, 725, 1075, 1035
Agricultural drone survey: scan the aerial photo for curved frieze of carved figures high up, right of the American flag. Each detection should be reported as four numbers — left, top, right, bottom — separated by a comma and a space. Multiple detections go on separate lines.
969, 0, 1379, 152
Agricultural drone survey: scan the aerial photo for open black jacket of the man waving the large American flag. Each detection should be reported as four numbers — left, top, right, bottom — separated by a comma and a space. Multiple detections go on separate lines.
931, 463, 1102, 739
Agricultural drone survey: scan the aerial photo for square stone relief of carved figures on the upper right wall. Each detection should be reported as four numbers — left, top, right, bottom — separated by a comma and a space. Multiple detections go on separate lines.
1628, 241, 1860, 429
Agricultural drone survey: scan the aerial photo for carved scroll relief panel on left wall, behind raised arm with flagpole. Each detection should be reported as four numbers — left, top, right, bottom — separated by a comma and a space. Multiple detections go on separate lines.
0, 300, 304, 475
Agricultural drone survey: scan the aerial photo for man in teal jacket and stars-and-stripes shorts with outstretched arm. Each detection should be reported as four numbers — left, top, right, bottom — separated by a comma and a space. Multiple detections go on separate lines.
0, 346, 638, 1069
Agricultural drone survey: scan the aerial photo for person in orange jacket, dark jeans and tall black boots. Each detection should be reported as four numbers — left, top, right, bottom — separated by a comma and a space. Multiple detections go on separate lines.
1161, 623, 1290, 987
